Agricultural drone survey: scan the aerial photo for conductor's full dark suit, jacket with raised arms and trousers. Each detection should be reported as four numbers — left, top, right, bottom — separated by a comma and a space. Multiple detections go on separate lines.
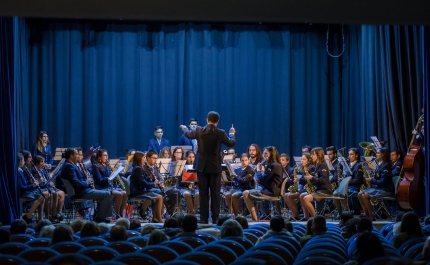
184, 124, 236, 223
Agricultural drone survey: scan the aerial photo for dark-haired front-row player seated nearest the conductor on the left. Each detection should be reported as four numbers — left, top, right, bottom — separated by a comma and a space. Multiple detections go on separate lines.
143, 150, 182, 216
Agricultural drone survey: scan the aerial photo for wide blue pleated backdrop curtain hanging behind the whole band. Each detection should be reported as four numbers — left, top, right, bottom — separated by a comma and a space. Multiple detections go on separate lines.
19, 19, 422, 157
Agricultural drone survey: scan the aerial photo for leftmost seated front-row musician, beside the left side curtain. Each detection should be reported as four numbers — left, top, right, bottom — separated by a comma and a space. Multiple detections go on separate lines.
18, 153, 45, 224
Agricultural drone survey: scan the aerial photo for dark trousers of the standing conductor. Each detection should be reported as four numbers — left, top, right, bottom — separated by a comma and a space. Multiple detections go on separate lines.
198, 172, 221, 223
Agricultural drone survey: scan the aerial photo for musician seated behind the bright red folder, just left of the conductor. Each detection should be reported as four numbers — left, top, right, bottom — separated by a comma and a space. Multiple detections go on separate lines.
179, 150, 200, 214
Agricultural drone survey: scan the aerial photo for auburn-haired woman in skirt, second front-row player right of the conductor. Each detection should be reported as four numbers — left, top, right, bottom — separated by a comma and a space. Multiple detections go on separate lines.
300, 147, 333, 221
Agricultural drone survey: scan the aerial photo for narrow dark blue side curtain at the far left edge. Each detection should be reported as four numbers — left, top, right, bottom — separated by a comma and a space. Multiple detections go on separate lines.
0, 17, 19, 224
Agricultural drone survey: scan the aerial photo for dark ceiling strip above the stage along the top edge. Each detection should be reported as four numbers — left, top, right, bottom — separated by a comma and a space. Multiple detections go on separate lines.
0, 0, 430, 25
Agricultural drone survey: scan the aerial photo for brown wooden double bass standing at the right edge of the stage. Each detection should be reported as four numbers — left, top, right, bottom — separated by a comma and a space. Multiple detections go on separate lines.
397, 114, 425, 210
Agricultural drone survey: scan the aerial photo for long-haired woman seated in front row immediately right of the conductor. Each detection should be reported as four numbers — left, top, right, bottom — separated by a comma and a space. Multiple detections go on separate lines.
243, 146, 282, 222
